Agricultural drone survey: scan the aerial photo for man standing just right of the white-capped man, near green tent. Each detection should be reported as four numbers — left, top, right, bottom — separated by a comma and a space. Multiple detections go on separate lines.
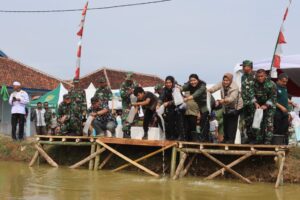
30, 102, 47, 135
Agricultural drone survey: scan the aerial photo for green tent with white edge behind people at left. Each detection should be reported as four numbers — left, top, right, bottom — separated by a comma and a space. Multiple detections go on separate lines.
29, 83, 68, 108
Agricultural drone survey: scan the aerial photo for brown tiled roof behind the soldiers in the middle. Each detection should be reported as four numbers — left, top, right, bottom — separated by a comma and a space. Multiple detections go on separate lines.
80, 68, 163, 89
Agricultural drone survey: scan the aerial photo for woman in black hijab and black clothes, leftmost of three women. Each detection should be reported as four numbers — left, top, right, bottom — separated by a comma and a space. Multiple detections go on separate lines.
157, 76, 184, 140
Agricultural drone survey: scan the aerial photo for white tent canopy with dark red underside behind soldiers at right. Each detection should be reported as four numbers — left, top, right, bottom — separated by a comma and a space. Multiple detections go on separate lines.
234, 55, 300, 97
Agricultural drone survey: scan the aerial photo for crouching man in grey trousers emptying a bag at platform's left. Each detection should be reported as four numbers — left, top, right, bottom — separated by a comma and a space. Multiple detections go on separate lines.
88, 97, 117, 137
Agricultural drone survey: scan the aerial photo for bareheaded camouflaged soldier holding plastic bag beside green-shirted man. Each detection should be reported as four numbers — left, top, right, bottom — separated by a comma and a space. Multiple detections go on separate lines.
253, 69, 277, 144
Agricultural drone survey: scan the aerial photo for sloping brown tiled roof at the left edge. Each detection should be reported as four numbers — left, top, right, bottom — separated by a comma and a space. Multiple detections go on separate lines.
0, 57, 68, 90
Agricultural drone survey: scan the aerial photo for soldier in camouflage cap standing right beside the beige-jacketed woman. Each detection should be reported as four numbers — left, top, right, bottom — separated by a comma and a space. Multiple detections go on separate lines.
241, 60, 256, 143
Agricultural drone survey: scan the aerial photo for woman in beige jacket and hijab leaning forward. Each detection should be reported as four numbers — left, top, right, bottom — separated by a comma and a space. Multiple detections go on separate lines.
208, 73, 243, 144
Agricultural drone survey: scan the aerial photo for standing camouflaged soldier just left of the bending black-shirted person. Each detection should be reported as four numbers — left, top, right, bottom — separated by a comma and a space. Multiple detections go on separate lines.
120, 73, 137, 137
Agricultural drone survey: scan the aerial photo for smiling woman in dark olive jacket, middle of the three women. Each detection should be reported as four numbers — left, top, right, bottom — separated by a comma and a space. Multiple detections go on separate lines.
182, 74, 209, 141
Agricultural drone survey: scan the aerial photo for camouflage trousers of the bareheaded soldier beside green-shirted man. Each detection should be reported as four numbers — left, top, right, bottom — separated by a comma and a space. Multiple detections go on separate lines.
256, 109, 275, 144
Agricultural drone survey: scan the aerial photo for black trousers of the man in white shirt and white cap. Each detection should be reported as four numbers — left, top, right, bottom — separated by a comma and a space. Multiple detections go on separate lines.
11, 113, 25, 140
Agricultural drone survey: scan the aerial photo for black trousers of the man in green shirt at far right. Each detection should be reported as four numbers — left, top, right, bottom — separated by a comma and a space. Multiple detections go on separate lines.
274, 110, 289, 145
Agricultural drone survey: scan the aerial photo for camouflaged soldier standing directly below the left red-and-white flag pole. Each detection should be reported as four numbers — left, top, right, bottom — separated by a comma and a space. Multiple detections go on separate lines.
68, 79, 87, 115
